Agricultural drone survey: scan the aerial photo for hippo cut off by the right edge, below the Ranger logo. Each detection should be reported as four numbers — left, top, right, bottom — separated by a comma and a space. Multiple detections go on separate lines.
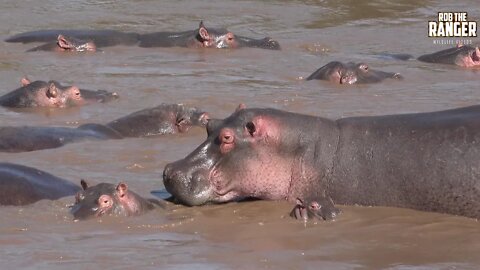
382, 44, 480, 68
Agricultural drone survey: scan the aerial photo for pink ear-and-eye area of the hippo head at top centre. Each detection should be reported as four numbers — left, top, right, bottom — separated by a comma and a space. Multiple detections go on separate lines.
196, 21, 239, 49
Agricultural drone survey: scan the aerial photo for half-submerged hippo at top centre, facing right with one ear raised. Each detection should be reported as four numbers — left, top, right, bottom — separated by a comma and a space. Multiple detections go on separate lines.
139, 22, 280, 50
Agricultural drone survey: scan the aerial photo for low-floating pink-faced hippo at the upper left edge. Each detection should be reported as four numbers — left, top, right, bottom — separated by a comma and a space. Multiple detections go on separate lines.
0, 78, 118, 108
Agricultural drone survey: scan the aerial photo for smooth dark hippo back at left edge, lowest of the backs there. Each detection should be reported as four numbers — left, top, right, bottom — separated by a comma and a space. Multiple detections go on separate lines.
0, 162, 80, 206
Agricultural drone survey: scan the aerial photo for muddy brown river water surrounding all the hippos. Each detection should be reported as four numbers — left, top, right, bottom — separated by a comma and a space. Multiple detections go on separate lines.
0, 0, 480, 269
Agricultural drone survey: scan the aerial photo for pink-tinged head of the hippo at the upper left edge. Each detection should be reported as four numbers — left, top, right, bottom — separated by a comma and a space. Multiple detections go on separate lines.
22, 78, 84, 108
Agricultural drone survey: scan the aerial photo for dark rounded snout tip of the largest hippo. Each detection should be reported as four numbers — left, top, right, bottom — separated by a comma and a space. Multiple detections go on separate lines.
163, 161, 211, 206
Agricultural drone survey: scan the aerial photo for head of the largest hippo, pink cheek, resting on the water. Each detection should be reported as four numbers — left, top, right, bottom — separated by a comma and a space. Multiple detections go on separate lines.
163, 106, 334, 205
